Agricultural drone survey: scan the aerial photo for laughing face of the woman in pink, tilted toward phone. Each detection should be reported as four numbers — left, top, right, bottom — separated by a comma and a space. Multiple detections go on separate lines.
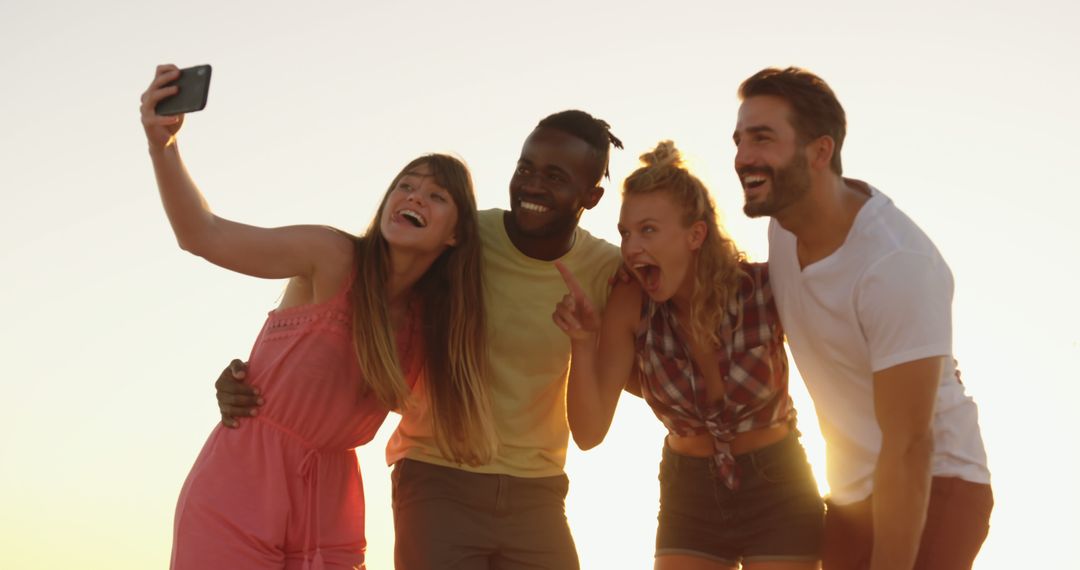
379, 163, 458, 253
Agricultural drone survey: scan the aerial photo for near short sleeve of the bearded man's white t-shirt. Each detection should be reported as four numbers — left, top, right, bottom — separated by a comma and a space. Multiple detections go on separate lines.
855, 250, 953, 372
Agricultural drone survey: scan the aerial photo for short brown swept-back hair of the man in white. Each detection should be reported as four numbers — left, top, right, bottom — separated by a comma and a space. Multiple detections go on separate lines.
739, 67, 848, 174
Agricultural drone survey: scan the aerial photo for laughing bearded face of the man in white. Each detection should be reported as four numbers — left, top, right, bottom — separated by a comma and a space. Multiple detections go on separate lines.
733, 95, 810, 218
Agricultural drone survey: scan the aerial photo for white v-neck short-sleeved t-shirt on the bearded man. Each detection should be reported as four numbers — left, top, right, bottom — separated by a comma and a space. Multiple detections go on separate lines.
769, 182, 990, 504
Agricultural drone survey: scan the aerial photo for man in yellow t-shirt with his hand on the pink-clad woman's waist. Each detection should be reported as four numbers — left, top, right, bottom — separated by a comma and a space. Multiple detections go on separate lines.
217, 110, 622, 570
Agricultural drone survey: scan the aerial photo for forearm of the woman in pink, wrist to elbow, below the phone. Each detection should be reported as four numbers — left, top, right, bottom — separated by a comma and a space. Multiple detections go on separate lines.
150, 139, 215, 255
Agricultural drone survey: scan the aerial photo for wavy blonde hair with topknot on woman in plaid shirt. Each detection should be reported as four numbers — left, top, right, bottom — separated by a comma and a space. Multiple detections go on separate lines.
622, 140, 746, 344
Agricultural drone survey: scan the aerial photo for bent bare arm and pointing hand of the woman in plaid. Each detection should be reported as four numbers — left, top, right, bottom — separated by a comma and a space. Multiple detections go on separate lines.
552, 262, 642, 449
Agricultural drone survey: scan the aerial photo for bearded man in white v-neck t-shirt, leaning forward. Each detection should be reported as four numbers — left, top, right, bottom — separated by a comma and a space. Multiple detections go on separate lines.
734, 68, 994, 570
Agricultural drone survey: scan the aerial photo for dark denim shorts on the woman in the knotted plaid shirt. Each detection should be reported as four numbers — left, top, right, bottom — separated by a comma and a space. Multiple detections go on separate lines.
657, 430, 825, 566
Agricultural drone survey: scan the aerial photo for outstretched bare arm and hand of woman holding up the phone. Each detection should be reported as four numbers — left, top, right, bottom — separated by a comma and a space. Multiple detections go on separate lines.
140, 65, 352, 279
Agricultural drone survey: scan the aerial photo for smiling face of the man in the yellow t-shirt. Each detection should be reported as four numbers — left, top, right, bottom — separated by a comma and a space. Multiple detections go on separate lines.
508, 126, 604, 238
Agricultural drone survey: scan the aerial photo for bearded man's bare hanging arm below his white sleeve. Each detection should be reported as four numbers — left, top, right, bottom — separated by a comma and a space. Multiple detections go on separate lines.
870, 356, 943, 570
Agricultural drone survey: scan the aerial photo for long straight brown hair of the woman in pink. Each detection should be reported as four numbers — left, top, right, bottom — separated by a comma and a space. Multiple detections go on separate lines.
352, 154, 497, 465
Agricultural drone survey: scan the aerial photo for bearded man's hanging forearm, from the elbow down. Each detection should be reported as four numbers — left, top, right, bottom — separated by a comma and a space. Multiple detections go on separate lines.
870, 433, 933, 570
